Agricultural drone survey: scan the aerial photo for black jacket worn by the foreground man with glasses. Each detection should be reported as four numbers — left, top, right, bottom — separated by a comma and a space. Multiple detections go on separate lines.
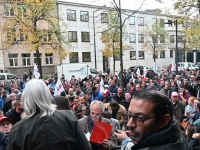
132, 120, 189, 150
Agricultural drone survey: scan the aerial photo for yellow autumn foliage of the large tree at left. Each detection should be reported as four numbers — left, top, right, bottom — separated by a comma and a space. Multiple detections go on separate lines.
2, 0, 70, 59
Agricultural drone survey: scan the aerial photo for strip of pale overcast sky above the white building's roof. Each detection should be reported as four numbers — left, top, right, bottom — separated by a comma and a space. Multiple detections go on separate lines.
62, 0, 173, 13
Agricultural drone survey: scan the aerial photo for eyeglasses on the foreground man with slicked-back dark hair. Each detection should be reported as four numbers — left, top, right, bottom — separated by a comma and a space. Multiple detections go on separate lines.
126, 112, 156, 126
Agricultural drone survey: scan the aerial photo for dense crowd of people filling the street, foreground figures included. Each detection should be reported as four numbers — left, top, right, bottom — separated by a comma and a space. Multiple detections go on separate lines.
0, 67, 200, 150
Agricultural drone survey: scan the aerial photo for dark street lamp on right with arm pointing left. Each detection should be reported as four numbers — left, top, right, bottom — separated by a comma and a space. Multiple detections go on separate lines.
164, 20, 178, 74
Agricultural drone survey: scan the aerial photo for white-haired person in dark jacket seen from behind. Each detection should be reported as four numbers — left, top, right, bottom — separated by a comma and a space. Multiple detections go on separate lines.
7, 79, 91, 150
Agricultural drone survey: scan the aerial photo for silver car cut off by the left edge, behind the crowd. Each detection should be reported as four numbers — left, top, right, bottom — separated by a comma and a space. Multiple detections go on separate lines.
0, 73, 20, 86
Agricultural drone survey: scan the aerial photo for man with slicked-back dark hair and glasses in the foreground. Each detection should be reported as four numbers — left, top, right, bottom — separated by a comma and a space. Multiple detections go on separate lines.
115, 90, 189, 150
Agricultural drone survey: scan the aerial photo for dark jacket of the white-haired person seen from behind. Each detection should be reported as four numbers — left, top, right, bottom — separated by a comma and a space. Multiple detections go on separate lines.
7, 110, 91, 150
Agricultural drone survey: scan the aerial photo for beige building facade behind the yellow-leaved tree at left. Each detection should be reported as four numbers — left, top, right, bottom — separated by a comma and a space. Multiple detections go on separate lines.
0, 2, 61, 77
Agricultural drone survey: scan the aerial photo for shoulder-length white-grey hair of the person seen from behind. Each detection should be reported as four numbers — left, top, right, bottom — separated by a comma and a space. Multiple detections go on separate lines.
22, 79, 56, 118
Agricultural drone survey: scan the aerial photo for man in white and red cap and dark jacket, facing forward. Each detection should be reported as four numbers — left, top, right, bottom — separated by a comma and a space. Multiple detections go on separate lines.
171, 92, 186, 123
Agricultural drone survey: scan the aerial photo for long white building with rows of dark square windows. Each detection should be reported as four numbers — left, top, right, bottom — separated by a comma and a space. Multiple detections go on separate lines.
57, 1, 191, 71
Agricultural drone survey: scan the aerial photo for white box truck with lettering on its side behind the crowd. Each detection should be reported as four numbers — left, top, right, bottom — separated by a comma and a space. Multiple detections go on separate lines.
57, 64, 99, 81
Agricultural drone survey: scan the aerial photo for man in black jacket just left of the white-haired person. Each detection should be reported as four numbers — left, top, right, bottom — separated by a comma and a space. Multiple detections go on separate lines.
6, 100, 24, 125
